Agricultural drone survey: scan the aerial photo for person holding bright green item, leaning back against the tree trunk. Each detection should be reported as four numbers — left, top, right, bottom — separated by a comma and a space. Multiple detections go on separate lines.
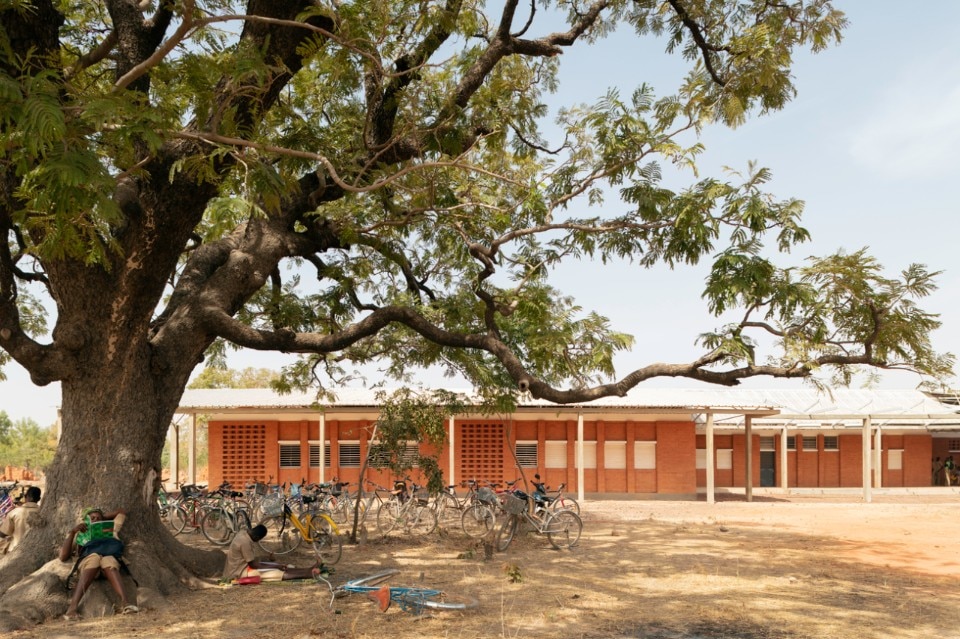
60, 508, 139, 621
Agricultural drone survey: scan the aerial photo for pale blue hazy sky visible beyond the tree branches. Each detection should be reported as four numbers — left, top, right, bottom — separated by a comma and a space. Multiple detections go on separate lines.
0, 0, 960, 426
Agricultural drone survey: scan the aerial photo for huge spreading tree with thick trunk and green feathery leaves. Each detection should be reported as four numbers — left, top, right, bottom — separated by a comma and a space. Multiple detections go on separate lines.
0, 0, 950, 624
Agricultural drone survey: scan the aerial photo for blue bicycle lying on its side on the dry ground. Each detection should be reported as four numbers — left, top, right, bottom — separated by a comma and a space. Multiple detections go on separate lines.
317, 568, 479, 615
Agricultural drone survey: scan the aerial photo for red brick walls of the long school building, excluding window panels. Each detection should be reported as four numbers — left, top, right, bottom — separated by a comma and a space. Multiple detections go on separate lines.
209, 412, 949, 494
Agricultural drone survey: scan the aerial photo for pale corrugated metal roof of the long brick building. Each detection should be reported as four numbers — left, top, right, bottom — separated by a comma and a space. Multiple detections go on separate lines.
178, 388, 960, 427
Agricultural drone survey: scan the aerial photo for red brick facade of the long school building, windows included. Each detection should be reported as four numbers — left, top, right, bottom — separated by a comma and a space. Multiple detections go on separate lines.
202, 412, 949, 495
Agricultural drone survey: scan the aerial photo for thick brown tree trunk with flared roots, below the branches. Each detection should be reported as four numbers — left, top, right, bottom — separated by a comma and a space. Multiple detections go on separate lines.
0, 366, 223, 633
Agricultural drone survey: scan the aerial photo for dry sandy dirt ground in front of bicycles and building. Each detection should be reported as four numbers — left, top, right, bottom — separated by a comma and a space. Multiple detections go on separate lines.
7, 495, 960, 639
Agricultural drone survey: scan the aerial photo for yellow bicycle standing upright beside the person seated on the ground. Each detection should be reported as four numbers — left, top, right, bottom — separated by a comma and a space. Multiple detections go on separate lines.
258, 501, 343, 566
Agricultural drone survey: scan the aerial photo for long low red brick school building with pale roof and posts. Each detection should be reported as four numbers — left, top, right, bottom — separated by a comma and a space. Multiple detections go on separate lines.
171, 389, 960, 501
